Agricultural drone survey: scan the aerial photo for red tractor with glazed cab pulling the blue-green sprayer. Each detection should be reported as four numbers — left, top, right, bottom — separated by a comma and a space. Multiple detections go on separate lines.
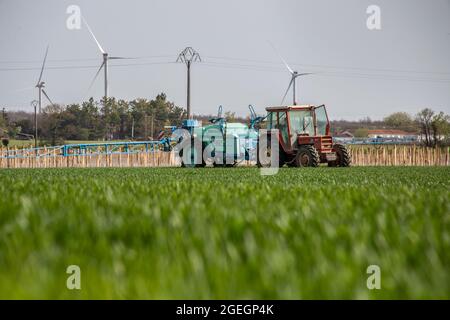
258, 105, 351, 167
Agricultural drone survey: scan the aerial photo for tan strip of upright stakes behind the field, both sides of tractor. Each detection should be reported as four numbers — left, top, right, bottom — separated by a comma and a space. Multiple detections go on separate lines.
0, 145, 450, 168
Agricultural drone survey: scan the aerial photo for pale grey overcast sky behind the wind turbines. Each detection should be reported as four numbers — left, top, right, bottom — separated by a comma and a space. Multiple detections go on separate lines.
0, 0, 450, 119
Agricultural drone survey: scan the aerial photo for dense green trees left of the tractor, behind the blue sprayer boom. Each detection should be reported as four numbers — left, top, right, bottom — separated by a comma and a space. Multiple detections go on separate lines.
0, 93, 186, 145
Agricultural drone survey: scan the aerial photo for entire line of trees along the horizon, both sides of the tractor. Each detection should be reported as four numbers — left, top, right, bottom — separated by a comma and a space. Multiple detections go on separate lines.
0, 93, 450, 147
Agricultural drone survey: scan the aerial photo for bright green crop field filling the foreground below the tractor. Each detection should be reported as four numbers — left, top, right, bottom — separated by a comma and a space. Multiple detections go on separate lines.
0, 167, 450, 299
